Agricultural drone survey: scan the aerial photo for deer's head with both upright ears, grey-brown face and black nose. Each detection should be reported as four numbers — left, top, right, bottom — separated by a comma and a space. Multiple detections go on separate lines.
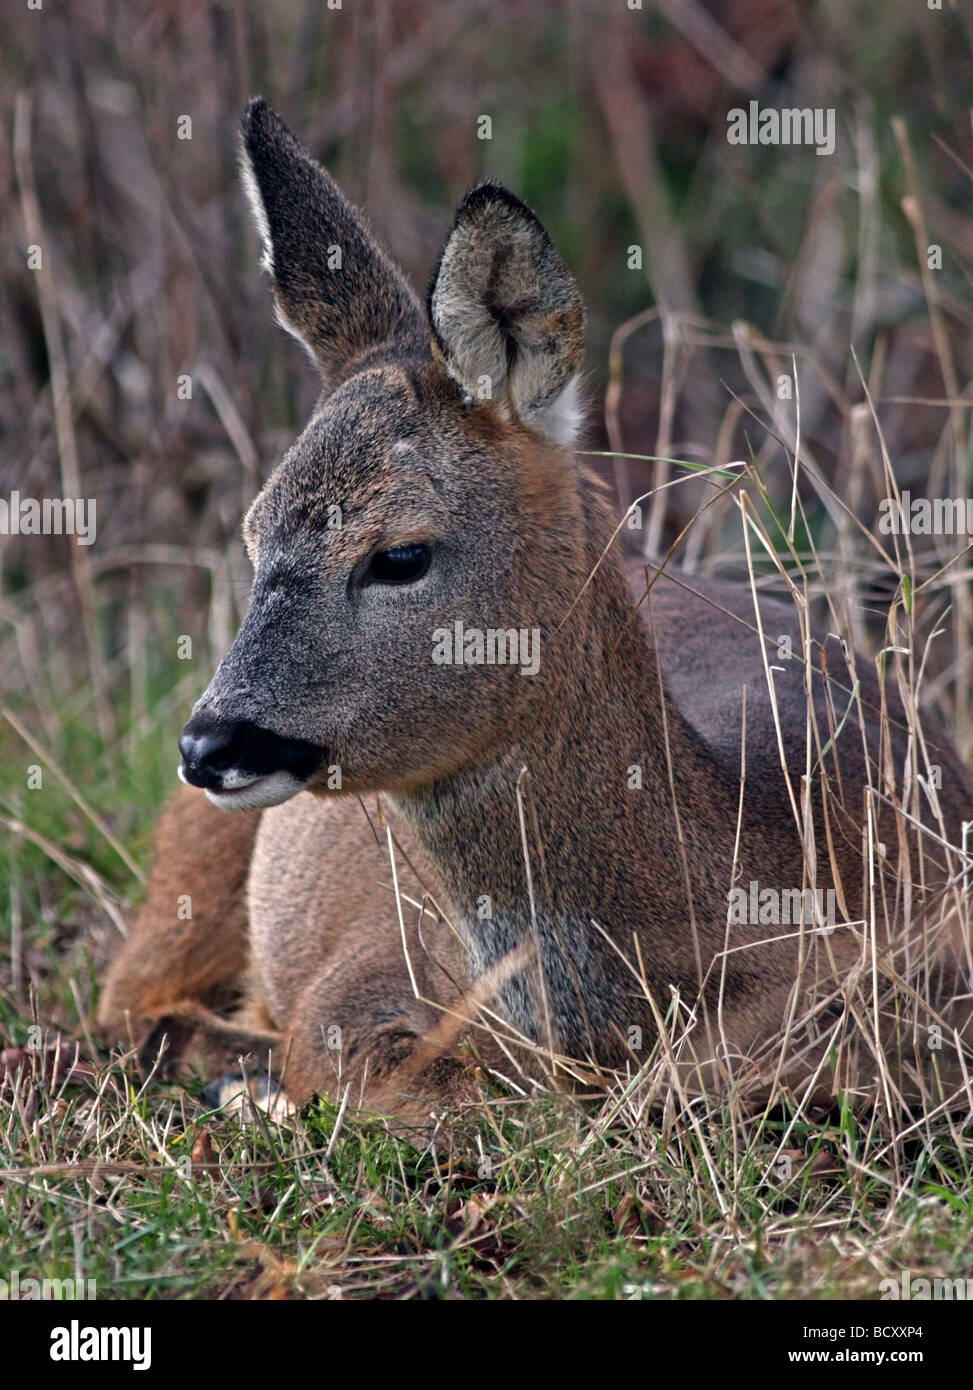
179, 100, 585, 809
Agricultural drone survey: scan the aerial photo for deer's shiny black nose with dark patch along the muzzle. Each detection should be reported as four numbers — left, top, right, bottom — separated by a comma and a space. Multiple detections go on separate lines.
179, 710, 325, 791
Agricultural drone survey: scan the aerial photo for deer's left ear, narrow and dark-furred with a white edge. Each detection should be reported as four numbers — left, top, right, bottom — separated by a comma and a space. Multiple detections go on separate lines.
242, 97, 423, 381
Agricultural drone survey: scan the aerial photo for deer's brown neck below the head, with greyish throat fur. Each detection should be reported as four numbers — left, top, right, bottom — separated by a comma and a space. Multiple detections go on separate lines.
398, 542, 712, 1055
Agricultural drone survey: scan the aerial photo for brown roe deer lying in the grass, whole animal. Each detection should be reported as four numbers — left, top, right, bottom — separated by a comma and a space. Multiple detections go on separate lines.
100, 100, 973, 1109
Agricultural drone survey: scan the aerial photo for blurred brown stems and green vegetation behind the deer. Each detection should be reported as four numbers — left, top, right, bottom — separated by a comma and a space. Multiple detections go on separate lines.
0, 0, 973, 998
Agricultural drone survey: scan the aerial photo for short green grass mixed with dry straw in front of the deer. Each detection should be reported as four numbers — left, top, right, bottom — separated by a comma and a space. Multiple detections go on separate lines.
0, 1028, 973, 1300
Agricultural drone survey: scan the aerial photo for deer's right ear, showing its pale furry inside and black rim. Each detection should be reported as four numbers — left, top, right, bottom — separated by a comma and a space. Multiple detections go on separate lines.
428, 183, 584, 443
